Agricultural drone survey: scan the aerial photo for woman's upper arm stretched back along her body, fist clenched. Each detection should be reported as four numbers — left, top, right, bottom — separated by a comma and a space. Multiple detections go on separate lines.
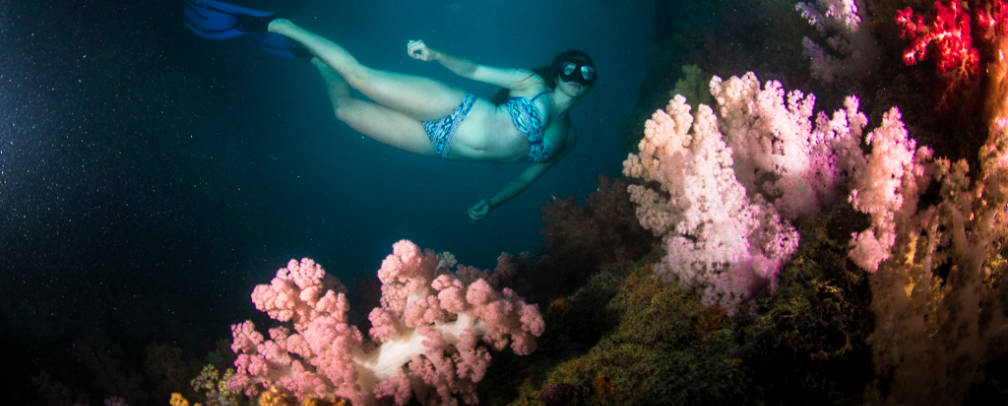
406, 39, 542, 90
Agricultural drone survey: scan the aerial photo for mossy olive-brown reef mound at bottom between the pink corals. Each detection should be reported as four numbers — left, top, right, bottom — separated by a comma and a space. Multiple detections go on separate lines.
512, 263, 748, 405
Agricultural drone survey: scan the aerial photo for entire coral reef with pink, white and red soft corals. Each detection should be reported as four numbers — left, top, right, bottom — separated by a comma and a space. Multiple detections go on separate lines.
153, 0, 1008, 405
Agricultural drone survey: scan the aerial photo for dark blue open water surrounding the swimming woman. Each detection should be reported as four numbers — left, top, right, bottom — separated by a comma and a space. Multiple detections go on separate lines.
0, 0, 652, 400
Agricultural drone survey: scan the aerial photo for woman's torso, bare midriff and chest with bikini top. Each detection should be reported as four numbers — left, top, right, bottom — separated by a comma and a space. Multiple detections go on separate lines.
452, 92, 568, 162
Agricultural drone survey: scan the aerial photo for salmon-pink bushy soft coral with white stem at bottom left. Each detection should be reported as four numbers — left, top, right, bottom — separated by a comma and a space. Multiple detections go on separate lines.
228, 240, 545, 405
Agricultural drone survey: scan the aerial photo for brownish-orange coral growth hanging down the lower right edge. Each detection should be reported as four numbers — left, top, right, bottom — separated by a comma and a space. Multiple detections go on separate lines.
858, 116, 1008, 404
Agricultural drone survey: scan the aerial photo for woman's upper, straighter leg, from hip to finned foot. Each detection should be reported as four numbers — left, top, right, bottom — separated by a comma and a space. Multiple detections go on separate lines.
269, 18, 465, 121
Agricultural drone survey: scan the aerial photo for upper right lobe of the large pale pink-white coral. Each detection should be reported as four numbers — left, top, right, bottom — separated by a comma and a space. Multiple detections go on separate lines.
711, 73, 868, 221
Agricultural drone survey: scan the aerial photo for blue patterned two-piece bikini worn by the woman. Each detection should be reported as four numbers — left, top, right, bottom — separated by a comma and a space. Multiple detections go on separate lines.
423, 91, 553, 162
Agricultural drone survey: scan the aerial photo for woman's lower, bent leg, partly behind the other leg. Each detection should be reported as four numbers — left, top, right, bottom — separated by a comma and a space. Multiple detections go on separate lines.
311, 57, 436, 156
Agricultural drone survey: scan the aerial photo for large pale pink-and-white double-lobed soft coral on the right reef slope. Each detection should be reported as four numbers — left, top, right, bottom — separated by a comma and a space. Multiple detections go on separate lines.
623, 73, 883, 310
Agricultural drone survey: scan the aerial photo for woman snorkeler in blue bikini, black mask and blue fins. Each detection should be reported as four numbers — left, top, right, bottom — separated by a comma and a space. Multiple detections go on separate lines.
185, 0, 596, 221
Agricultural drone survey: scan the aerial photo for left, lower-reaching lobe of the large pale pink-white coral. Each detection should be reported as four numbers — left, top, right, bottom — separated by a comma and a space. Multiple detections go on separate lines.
623, 95, 798, 311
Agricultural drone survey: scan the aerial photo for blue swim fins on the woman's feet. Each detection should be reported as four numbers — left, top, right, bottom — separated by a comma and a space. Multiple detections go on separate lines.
182, 0, 311, 59
